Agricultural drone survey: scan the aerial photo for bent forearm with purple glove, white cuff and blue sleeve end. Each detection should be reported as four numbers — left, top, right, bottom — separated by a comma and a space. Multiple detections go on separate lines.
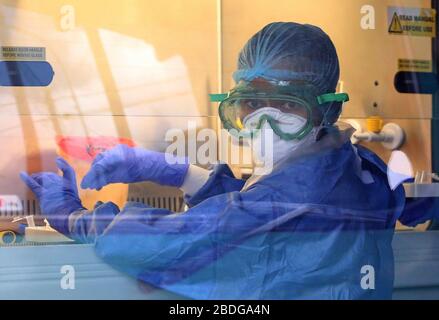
81, 145, 248, 205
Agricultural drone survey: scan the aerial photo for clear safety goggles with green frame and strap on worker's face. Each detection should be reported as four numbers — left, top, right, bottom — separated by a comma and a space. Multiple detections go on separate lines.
210, 81, 349, 140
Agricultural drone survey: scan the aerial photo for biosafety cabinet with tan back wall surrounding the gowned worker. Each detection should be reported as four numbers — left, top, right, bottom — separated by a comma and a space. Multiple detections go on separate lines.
0, 0, 439, 299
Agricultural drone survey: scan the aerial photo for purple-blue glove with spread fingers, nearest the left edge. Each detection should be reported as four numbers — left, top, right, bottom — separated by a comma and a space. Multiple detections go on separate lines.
20, 158, 85, 235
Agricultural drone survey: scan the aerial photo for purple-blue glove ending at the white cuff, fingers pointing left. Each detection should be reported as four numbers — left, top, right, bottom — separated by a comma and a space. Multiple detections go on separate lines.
81, 144, 189, 190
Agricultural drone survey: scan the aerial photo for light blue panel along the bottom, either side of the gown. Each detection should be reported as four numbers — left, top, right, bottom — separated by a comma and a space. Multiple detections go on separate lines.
0, 231, 439, 300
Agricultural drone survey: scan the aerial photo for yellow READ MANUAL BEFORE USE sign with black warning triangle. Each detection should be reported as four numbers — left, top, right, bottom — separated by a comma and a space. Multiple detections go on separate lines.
387, 7, 436, 38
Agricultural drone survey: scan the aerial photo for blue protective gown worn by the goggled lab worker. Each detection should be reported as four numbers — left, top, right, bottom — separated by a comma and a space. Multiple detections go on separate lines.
62, 127, 431, 299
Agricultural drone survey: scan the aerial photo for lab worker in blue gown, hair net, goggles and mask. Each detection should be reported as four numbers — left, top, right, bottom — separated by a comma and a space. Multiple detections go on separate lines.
21, 22, 433, 299
